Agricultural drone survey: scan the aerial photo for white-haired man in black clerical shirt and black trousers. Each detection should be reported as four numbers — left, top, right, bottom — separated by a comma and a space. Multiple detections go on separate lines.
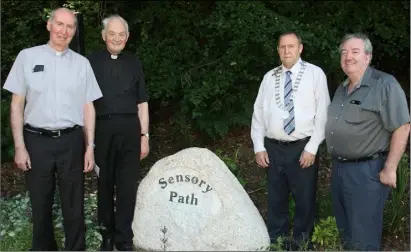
88, 15, 149, 251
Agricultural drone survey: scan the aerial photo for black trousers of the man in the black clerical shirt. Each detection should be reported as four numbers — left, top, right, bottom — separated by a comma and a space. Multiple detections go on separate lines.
95, 115, 141, 245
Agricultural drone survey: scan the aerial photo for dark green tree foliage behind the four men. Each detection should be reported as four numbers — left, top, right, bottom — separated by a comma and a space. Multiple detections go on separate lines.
1, 0, 410, 161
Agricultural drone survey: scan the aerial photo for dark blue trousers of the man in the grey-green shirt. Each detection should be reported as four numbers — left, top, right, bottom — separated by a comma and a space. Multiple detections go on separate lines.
331, 158, 390, 251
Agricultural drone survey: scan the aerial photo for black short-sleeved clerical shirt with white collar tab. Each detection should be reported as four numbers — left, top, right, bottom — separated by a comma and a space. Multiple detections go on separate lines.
87, 49, 148, 116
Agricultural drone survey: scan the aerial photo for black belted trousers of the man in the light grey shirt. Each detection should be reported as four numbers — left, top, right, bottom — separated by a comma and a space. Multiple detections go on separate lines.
24, 128, 85, 251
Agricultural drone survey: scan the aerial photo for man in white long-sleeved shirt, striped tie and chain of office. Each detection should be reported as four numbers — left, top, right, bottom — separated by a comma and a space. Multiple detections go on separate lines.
251, 32, 330, 250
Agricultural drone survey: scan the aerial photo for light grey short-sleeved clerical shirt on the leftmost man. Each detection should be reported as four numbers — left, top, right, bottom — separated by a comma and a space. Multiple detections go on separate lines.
3, 44, 102, 129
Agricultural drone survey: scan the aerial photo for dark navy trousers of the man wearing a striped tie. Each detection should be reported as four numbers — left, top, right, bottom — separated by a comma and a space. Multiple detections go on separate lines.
264, 138, 319, 250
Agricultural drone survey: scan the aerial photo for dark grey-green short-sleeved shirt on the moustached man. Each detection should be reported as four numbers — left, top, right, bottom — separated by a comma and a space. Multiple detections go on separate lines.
325, 67, 410, 159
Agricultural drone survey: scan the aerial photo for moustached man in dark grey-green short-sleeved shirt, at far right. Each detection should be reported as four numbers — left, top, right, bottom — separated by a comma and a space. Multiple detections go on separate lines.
325, 34, 410, 250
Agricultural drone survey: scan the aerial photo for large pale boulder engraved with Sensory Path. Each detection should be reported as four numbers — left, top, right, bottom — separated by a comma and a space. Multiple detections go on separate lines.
132, 148, 270, 251
